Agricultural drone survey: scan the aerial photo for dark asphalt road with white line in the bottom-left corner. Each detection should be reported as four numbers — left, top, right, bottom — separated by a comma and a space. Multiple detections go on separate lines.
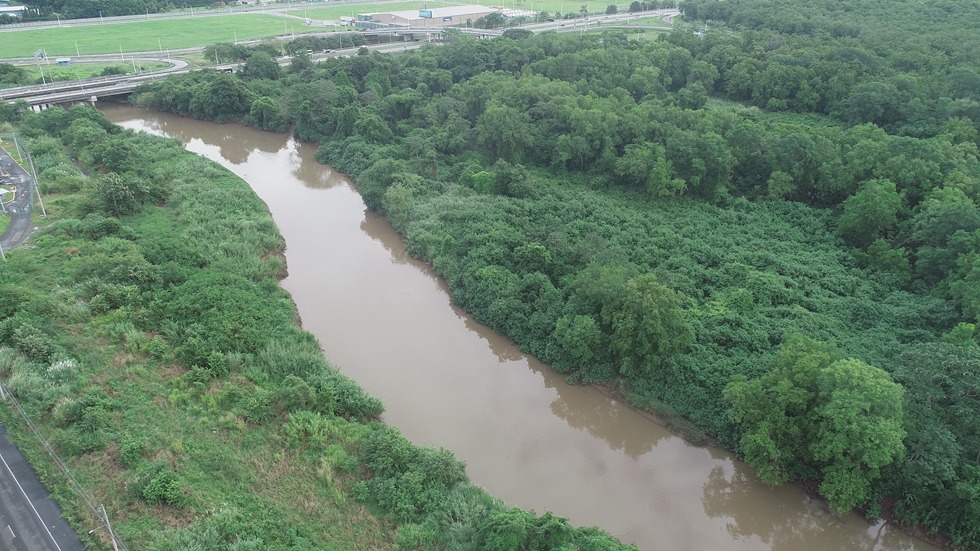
0, 426, 85, 551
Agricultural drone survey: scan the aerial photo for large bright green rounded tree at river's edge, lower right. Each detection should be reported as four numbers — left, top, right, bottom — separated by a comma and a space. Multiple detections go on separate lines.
724, 337, 905, 514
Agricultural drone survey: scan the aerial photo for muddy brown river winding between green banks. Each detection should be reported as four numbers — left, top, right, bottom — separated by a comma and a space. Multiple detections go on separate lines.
101, 105, 936, 551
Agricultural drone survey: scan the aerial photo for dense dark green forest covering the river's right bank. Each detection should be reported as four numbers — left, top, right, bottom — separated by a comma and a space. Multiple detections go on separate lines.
126, 0, 980, 548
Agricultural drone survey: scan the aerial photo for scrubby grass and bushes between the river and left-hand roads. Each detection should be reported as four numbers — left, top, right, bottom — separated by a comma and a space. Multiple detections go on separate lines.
0, 105, 636, 551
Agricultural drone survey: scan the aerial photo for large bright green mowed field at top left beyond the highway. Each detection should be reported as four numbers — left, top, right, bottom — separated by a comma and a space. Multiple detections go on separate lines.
0, 14, 323, 58
